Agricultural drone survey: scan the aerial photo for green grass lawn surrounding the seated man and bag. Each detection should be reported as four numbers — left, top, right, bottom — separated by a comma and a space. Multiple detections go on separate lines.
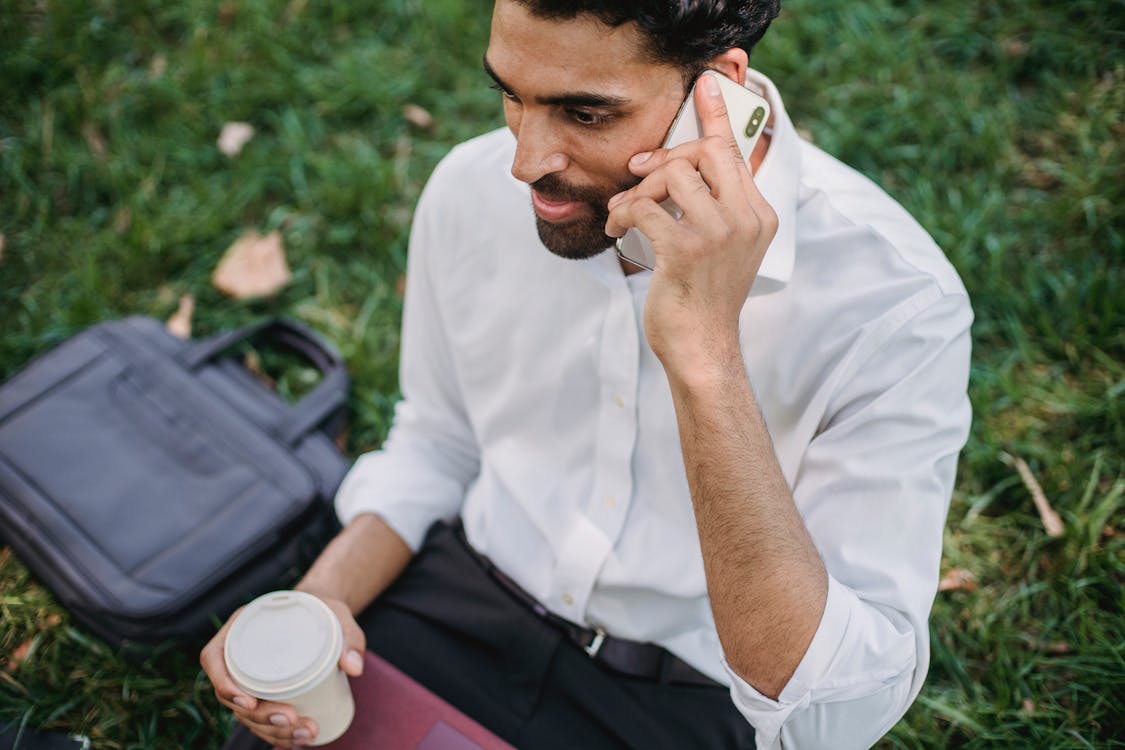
0, 0, 1125, 749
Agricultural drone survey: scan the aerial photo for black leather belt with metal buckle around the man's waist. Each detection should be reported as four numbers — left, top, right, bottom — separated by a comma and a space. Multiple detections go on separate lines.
456, 523, 721, 687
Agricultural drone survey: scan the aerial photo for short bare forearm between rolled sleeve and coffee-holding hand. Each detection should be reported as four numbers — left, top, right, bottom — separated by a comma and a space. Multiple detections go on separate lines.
296, 514, 413, 614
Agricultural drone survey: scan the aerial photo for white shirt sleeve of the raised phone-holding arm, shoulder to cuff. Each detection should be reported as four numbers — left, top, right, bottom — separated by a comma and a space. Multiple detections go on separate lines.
727, 288, 972, 750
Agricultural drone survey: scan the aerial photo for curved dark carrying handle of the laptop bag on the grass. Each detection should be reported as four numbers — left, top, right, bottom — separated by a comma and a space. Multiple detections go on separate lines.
180, 318, 348, 445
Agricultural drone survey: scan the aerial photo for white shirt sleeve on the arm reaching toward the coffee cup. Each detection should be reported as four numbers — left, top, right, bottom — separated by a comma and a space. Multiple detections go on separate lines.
336, 168, 479, 550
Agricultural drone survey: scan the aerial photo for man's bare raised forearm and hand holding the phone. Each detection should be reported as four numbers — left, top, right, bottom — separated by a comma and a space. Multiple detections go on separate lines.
605, 74, 828, 698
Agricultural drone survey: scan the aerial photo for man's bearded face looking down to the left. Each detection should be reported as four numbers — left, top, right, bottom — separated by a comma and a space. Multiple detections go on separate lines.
485, 0, 685, 259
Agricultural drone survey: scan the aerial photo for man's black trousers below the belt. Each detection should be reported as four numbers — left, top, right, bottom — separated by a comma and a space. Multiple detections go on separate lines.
226, 525, 754, 750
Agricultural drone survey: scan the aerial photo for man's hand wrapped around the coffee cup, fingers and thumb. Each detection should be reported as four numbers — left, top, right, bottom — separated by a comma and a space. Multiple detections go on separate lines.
199, 597, 367, 748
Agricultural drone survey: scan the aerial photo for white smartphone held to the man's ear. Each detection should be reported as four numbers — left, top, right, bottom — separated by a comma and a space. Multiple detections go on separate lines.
618, 71, 770, 271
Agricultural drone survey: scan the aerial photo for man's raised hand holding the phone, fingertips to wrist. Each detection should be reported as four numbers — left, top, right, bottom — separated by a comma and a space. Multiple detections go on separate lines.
605, 73, 777, 376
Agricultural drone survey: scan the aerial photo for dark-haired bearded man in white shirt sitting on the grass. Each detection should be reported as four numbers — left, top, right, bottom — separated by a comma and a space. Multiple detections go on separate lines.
201, 0, 972, 748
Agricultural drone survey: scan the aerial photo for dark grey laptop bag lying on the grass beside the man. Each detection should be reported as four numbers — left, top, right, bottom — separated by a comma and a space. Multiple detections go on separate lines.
0, 317, 348, 647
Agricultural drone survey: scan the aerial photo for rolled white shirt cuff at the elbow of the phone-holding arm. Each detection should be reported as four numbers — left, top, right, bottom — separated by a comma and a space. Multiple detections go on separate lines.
722, 576, 916, 750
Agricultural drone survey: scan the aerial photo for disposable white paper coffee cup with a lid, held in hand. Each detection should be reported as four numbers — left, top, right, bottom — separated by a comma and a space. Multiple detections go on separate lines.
223, 591, 356, 744
